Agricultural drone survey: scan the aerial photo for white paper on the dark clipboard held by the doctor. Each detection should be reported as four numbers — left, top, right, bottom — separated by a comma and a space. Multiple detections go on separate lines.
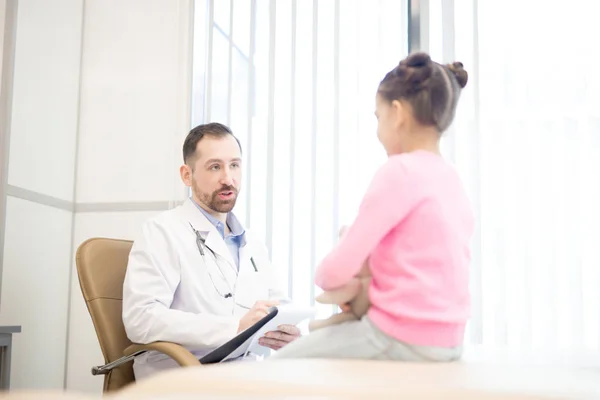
221, 304, 317, 362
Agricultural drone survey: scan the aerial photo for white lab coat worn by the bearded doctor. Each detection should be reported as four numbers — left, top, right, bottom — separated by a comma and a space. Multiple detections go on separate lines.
123, 199, 285, 379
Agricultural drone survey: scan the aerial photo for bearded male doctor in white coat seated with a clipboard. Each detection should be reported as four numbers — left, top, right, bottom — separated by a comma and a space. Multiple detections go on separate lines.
123, 123, 300, 379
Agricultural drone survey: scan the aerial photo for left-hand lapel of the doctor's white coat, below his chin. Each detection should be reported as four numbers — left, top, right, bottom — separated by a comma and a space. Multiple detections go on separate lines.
183, 199, 237, 276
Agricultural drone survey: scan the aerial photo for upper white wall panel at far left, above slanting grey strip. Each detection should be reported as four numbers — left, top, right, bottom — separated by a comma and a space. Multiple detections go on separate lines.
8, 0, 83, 201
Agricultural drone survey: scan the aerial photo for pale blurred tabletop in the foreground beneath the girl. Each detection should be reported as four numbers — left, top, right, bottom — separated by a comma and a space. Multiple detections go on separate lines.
116, 359, 600, 400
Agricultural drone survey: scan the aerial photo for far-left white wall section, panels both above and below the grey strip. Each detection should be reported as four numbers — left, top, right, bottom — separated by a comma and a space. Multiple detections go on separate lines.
0, 0, 83, 388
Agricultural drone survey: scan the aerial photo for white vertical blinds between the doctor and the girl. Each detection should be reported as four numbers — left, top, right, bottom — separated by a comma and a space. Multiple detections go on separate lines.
192, 0, 407, 313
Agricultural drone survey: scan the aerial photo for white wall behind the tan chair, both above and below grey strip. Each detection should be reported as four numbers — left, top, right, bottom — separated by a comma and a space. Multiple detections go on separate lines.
67, 0, 192, 393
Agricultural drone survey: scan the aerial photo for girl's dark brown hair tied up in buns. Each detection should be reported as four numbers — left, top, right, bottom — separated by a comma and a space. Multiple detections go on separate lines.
378, 53, 469, 133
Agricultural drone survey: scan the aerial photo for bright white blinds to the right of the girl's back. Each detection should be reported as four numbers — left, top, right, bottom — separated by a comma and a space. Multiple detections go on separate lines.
423, 0, 600, 350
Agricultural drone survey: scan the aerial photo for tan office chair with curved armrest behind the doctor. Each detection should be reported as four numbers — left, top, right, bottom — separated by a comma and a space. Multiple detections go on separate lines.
76, 238, 200, 392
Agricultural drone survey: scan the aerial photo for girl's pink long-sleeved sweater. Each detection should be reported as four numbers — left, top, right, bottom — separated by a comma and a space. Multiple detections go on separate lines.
316, 151, 474, 347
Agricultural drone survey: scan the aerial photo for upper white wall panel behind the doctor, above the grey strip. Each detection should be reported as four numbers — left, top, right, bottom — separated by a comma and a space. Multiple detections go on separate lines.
77, 0, 191, 203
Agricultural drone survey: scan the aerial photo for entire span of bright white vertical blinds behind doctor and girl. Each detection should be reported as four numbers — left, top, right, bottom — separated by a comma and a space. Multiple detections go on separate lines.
192, 0, 600, 349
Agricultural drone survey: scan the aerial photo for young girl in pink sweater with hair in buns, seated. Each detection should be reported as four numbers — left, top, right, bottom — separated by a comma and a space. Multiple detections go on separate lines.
272, 53, 474, 361
